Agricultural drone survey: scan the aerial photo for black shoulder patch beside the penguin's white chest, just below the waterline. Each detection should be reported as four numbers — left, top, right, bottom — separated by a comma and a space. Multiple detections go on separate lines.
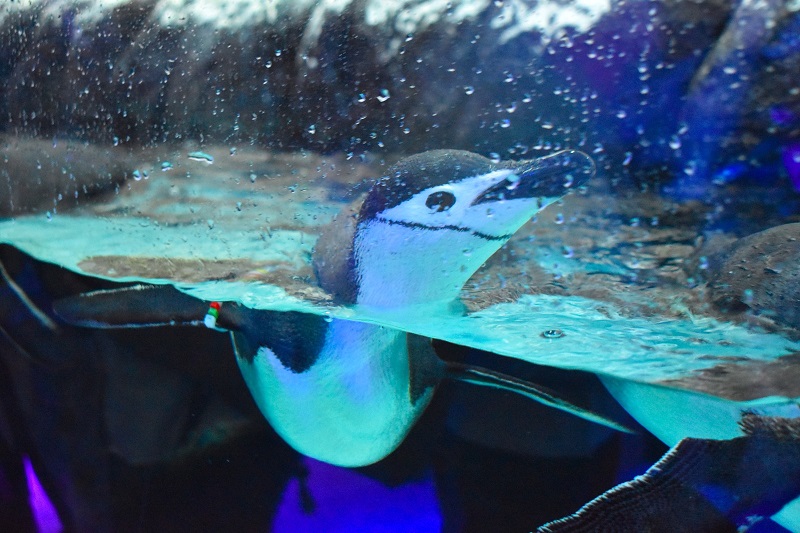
233, 310, 328, 374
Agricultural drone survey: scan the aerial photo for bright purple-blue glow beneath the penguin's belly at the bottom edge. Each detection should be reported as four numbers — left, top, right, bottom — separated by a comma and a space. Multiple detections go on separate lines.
273, 458, 442, 533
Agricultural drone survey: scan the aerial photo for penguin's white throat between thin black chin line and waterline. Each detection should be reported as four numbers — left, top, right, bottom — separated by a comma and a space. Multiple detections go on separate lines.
353, 220, 505, 308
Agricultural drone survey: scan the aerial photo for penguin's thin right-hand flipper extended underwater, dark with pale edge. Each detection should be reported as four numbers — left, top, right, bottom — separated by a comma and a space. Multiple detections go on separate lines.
443, 362, 635, 433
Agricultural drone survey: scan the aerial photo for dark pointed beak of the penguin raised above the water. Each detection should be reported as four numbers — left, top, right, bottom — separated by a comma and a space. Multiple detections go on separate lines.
472, 150, 595, 205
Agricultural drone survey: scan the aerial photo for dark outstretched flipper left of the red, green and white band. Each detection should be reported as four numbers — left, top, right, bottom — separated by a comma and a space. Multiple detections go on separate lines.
53, 285, 214, 328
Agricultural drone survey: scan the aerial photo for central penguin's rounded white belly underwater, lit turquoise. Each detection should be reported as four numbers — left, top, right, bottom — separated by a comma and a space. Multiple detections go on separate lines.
238, 320, 431, 466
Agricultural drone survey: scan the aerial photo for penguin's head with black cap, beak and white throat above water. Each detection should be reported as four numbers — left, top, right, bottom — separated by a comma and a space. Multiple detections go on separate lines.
352, 150, 595, 307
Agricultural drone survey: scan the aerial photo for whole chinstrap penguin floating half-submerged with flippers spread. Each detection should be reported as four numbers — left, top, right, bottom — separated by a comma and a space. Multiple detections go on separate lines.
55, 150, 628, 467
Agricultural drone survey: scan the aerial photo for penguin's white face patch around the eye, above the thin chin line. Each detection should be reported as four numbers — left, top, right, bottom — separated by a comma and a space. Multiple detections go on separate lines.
375, 169, 556, 240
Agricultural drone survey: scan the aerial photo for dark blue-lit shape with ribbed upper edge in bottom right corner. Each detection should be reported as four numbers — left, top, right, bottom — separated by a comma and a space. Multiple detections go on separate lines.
538, 413, 800, 533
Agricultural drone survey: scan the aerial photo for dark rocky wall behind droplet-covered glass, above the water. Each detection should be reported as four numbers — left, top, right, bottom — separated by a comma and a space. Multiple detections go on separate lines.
0, 0, 800, 197
